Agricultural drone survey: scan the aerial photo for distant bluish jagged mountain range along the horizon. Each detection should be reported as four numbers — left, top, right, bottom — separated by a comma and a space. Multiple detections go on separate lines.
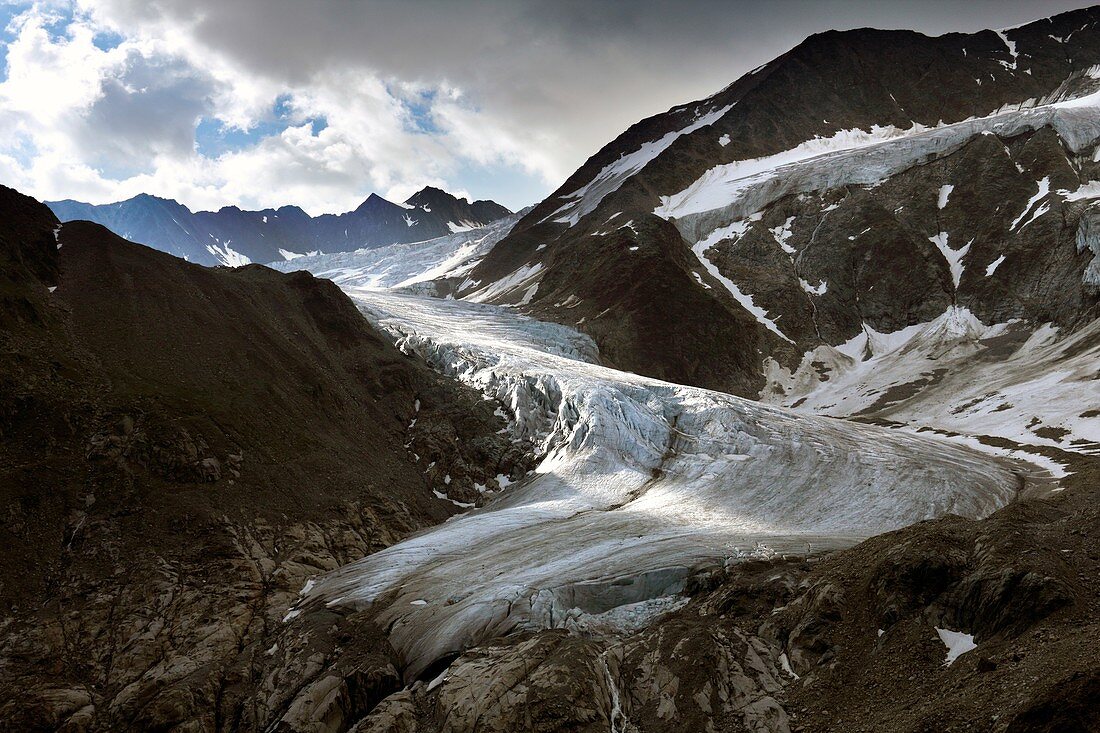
46, 187, 512, 266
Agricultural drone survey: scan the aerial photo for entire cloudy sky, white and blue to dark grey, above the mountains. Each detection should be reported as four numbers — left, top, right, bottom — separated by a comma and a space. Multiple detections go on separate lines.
0, 0, 1089, 215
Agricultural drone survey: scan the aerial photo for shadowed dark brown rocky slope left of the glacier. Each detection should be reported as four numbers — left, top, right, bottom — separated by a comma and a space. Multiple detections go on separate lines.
0, 188, 527, 731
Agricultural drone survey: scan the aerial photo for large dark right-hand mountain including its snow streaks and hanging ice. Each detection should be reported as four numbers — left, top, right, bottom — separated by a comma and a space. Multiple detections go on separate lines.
459, 9, 1100, 394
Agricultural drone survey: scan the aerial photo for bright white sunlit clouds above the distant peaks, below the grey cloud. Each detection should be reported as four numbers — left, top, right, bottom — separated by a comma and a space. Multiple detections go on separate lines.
0, 6, 558, 214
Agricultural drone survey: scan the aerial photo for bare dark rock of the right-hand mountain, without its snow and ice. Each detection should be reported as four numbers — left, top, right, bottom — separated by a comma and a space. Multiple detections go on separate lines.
460, 8, 1100, 395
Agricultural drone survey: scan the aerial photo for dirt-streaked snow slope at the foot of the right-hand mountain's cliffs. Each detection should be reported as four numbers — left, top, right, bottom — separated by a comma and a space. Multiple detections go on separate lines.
760, 307, 1100, 464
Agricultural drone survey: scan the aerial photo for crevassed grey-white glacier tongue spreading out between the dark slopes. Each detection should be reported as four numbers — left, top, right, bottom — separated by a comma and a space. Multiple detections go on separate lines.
304, 291, 1020, 679
